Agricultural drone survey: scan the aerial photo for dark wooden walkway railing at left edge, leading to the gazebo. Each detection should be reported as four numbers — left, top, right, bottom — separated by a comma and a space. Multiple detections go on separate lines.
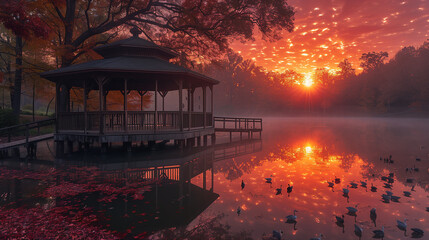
0, 118, 55, 143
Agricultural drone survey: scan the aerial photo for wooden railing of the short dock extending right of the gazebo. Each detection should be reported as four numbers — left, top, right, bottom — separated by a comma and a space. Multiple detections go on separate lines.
214, 117, 262, 131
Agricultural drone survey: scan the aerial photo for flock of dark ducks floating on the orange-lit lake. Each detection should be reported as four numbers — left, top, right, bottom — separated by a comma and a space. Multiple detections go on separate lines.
237, 156, 429, 240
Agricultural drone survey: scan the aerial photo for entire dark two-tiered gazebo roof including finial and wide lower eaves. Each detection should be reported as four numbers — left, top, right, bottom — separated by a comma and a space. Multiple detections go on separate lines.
40, 29, 219, 89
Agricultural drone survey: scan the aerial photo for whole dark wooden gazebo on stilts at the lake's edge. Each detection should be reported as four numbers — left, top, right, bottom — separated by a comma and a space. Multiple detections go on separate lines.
41, 29, 219, 156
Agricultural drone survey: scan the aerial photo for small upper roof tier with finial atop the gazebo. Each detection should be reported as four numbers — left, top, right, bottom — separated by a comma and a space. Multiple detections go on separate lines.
94, 28, 177, 61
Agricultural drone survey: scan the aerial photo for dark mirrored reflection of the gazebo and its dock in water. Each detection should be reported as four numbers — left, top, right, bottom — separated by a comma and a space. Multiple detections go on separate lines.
64, 140, 262, 235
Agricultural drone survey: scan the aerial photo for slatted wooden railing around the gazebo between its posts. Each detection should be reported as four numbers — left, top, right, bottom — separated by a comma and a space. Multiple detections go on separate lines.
58, 111, 213, 133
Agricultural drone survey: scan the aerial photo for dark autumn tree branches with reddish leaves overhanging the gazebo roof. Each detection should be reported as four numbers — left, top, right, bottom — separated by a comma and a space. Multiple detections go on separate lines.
38, 0, 294, 66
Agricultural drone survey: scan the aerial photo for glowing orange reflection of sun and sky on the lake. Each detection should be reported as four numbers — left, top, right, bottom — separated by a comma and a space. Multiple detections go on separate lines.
190, 142, 425, 239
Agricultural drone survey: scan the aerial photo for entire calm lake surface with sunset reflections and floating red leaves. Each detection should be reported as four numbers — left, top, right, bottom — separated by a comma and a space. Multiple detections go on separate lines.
0, 118, 429, 239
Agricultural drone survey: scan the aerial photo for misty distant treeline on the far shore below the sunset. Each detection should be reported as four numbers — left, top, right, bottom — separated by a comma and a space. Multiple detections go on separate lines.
203, 41, 429, 115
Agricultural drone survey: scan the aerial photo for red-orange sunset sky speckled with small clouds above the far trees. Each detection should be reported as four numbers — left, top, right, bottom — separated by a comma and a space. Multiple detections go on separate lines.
232, 0, 429, 73
